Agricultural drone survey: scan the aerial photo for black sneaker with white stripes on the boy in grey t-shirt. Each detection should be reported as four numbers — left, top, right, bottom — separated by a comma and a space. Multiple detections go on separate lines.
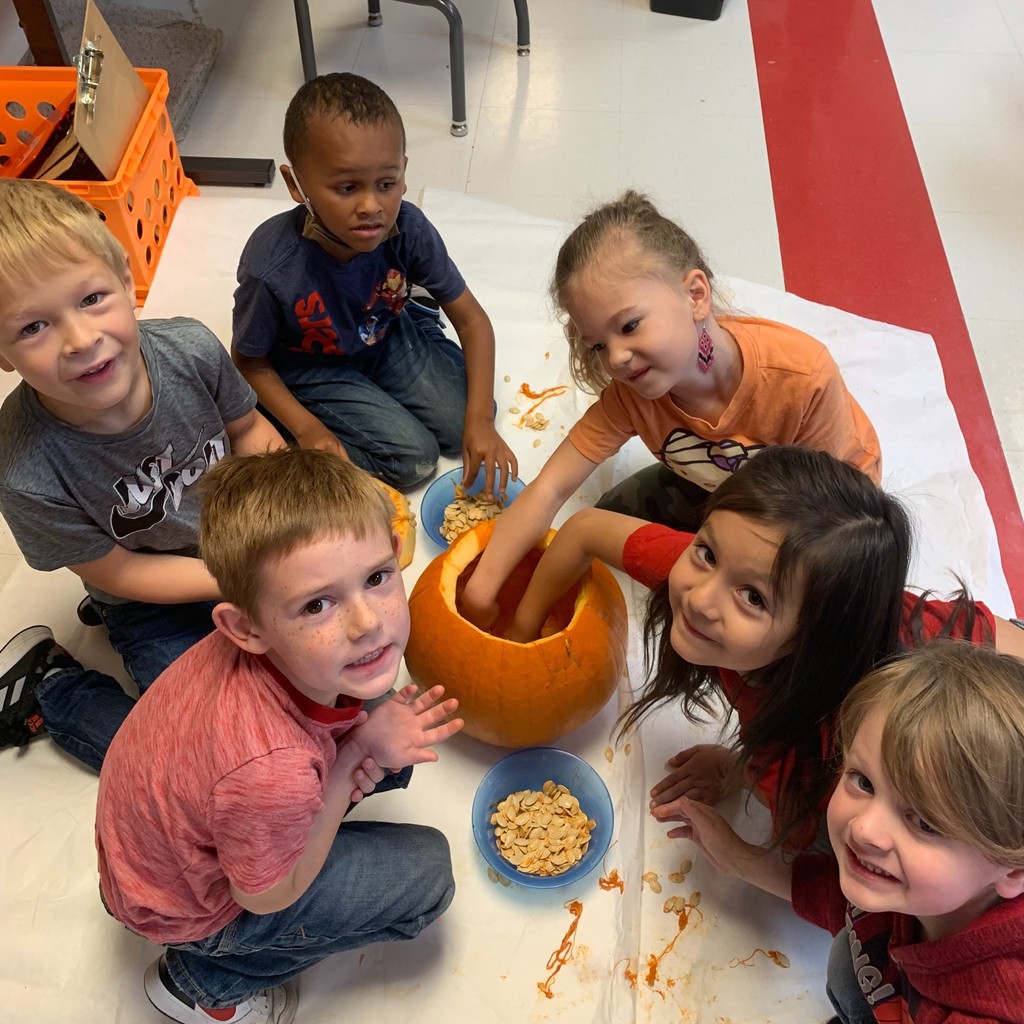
0, 626, 81, 750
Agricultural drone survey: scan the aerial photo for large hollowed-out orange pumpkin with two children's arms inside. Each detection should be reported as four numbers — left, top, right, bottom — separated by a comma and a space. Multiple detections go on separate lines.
406, 522, 627, 746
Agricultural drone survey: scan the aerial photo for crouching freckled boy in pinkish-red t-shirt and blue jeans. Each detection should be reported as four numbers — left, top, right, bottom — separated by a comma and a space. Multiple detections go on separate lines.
96, 449, 462, 1024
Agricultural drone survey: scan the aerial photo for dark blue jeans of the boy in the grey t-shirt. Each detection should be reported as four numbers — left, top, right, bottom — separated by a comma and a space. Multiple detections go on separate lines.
36, 600, 216, 771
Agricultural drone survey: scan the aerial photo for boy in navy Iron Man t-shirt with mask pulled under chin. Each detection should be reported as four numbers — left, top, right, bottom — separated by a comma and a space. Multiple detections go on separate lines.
231, 74, 518, 492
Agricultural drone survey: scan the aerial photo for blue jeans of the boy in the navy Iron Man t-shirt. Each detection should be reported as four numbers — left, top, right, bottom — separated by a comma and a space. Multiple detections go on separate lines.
272, 306, 466, 487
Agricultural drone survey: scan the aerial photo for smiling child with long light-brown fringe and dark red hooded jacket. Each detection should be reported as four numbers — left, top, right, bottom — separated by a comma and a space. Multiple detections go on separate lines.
676, 641, 1024, 1024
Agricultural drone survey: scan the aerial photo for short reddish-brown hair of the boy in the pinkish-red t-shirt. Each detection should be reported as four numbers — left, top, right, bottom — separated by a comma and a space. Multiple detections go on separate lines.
199, 447, 394, 618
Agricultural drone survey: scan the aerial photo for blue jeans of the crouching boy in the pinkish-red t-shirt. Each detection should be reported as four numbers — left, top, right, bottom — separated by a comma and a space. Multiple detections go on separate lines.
166, 821, 455, 1009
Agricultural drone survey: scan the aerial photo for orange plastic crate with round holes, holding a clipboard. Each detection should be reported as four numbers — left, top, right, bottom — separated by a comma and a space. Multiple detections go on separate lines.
0, 68, 199, 303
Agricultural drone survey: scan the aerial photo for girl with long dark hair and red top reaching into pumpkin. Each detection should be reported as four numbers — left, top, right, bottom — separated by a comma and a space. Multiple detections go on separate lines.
501, 445, 1024, 848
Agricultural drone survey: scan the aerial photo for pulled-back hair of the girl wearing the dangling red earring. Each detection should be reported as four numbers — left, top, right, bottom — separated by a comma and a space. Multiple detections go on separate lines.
551, 189, 714, 394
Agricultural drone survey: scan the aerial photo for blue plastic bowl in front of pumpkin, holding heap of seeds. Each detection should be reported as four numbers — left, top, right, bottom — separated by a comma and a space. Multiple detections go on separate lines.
473, 746, 615, 889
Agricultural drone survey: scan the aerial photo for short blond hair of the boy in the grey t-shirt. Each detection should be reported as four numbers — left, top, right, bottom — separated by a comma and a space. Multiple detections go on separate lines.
0, 178, 128, 294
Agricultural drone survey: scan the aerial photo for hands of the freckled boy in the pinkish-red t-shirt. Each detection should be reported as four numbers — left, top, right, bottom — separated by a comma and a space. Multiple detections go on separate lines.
348, 685, 463, 781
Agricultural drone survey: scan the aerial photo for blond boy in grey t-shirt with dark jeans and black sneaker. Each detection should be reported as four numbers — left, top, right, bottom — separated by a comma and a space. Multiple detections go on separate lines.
0, 179, 284, 769
